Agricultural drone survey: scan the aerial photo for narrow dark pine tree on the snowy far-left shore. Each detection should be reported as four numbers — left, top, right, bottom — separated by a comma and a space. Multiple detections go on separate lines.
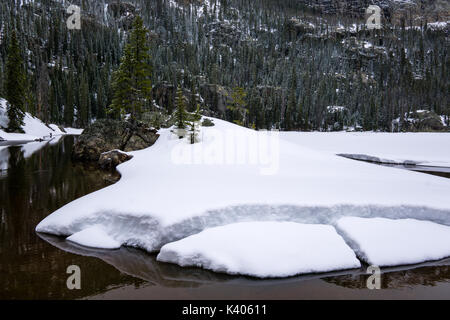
5, 31, 25, 132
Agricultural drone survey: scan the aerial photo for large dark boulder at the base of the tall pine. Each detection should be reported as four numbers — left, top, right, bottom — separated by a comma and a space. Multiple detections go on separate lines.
72, 119, 159, 161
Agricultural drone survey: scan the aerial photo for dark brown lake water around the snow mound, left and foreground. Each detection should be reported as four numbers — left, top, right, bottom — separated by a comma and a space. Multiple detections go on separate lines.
0, 137, 450, 299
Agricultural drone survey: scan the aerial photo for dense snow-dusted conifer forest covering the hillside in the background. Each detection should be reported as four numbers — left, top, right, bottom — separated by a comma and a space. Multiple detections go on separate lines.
0, 0, 450, 131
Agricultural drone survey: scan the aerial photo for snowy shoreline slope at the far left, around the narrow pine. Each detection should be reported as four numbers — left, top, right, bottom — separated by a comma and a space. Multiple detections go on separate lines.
0, 98, 83, 141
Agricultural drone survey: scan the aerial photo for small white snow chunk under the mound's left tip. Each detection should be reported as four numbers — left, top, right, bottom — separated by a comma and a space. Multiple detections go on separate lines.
67, 225, 120, 249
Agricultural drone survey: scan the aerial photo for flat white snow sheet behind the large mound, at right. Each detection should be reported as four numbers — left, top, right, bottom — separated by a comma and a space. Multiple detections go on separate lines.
280, 132, 450, 167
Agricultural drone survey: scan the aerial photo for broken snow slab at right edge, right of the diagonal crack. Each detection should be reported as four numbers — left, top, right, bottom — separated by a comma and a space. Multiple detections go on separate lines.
337, 217, 450, 266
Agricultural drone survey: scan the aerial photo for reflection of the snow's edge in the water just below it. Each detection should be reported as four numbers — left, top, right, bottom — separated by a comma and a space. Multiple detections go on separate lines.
40, 234, 450, 289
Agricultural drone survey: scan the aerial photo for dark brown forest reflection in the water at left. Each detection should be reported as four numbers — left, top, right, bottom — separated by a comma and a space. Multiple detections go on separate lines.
0, 137, 128, 299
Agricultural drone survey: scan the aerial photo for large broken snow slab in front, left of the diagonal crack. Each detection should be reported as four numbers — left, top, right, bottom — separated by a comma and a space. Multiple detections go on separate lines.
157, 222, 361, 278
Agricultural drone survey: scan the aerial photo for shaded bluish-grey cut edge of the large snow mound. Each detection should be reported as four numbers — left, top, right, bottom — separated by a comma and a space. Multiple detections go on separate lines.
36, 205, 450, 252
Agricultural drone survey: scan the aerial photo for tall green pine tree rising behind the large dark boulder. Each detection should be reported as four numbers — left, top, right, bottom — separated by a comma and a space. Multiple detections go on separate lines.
109, 16, 152, 120
